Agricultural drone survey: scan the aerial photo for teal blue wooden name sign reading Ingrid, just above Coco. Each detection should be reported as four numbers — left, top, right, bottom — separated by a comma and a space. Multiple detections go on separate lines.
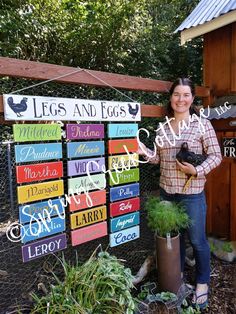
110, 212, 140, 232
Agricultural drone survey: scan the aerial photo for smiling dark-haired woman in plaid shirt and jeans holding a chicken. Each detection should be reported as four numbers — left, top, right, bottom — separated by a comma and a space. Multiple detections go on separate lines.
138, 78, 222, 308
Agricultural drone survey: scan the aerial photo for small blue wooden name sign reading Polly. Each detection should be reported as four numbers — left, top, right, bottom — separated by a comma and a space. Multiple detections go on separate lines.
110, 183, 139, 202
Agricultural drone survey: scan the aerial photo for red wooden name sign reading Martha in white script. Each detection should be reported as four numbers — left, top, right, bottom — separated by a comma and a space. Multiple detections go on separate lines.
16, 161, 63, 183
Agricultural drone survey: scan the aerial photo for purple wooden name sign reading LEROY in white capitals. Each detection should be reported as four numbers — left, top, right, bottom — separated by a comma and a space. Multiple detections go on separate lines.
21, 233, 67, 263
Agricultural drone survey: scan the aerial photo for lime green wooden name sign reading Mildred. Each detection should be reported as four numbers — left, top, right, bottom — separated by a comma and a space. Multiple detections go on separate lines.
13, 124, 61, 142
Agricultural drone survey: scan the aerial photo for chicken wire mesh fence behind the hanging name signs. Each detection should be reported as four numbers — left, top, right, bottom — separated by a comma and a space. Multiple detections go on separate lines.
0, 77, 162, 314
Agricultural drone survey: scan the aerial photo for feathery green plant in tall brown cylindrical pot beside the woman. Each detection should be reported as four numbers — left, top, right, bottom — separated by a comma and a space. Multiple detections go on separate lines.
146, 196, 190, 293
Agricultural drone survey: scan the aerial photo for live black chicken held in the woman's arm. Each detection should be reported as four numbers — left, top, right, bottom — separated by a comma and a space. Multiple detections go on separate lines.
176, 142, 207, 167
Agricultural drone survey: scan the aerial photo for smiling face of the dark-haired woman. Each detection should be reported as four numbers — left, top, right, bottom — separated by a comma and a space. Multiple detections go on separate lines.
170, 85, 194, 113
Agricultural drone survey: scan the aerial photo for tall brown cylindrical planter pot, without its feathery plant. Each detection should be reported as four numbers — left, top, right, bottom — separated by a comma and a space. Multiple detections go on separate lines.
155, 235, 181, 294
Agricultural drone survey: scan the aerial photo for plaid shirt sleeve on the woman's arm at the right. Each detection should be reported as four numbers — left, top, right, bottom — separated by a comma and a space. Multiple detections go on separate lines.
196, 119, 222, 177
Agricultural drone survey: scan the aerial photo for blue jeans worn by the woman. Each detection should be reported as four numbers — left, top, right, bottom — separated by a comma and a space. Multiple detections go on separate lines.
160, 188, 210, 284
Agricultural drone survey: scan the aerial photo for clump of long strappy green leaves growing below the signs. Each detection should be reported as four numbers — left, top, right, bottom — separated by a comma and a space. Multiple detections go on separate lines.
31, 252, 135, 314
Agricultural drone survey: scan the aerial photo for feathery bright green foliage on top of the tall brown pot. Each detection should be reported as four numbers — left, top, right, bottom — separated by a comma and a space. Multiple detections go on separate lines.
145, 196, 190, 237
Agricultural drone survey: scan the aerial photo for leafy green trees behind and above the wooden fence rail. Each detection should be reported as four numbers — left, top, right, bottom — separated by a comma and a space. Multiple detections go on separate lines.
0, 0, 202, 83
